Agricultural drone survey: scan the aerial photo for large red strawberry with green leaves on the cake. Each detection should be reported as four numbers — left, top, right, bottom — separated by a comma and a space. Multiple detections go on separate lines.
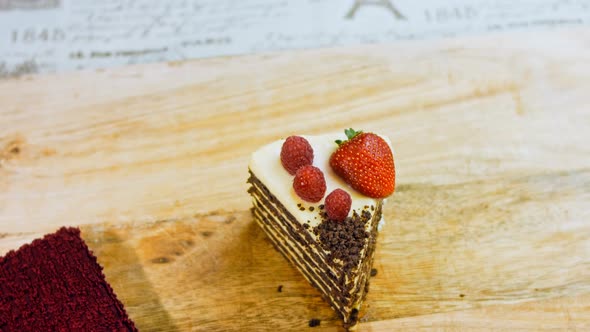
330, 128, 395, 198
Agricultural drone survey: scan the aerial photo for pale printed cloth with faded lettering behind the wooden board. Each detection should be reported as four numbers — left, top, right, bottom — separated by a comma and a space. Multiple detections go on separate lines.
0, 0, 590, 77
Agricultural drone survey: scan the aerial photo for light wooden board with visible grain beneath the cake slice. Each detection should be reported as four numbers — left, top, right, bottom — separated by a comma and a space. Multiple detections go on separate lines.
0, 30, 590, 331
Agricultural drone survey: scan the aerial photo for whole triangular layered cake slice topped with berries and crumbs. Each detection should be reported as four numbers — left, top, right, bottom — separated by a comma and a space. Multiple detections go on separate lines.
248, 129, 395, 328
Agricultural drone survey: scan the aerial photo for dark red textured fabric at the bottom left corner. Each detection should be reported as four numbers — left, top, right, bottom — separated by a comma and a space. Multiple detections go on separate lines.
0, 227, 137, 332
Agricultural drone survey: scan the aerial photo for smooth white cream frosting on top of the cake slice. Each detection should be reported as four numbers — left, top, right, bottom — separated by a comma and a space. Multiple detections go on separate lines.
249, 134, 391, 236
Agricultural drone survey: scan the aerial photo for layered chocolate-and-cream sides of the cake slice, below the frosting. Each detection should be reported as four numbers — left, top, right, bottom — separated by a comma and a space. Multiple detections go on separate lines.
248, 172, 381, 326
